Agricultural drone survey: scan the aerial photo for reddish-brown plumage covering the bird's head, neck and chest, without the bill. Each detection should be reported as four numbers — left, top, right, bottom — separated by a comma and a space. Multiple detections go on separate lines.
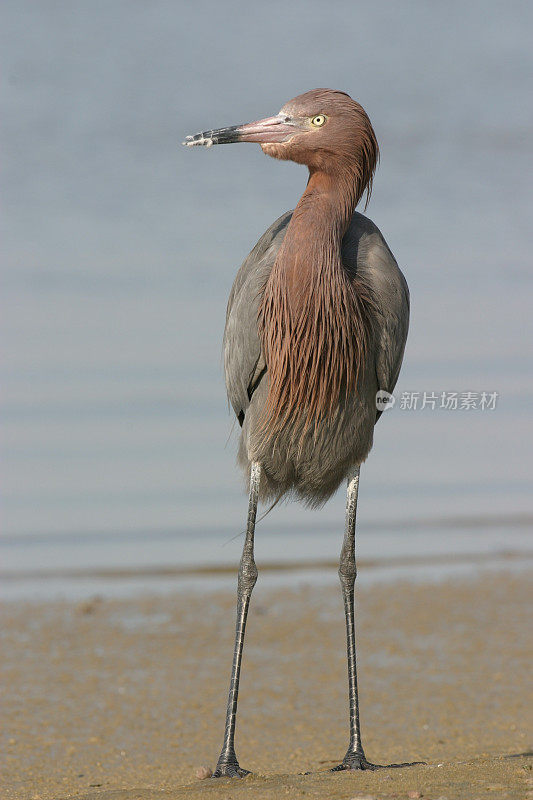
258, 90, 378, 437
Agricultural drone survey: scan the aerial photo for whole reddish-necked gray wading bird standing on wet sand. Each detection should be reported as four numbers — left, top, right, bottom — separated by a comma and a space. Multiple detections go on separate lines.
184, 89, 409, 777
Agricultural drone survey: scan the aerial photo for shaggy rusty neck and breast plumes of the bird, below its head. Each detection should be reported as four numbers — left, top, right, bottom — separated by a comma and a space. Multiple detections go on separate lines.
259, 164, 371, 435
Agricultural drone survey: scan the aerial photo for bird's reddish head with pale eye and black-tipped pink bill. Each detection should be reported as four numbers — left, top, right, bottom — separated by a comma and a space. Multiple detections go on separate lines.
184, 89, 379, 185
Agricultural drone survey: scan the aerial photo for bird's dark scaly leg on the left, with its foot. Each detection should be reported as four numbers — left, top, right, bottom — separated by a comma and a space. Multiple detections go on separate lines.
213, 461, 261, 778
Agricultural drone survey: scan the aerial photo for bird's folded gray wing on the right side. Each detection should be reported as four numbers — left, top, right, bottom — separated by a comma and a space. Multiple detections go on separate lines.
343, 213, 409, 419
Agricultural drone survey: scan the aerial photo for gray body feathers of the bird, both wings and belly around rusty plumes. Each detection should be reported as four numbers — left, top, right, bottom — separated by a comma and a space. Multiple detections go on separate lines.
224, 212, 409, 506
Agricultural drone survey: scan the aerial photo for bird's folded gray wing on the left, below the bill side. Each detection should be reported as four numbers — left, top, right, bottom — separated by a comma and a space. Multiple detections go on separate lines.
224, 211, 292, 425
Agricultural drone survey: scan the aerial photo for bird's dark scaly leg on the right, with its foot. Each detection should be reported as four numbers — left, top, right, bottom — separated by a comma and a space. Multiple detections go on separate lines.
334, 467, 377, 771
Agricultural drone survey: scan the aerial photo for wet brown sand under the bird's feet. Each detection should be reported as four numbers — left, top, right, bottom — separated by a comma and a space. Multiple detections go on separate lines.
1, 572, 533, 800
